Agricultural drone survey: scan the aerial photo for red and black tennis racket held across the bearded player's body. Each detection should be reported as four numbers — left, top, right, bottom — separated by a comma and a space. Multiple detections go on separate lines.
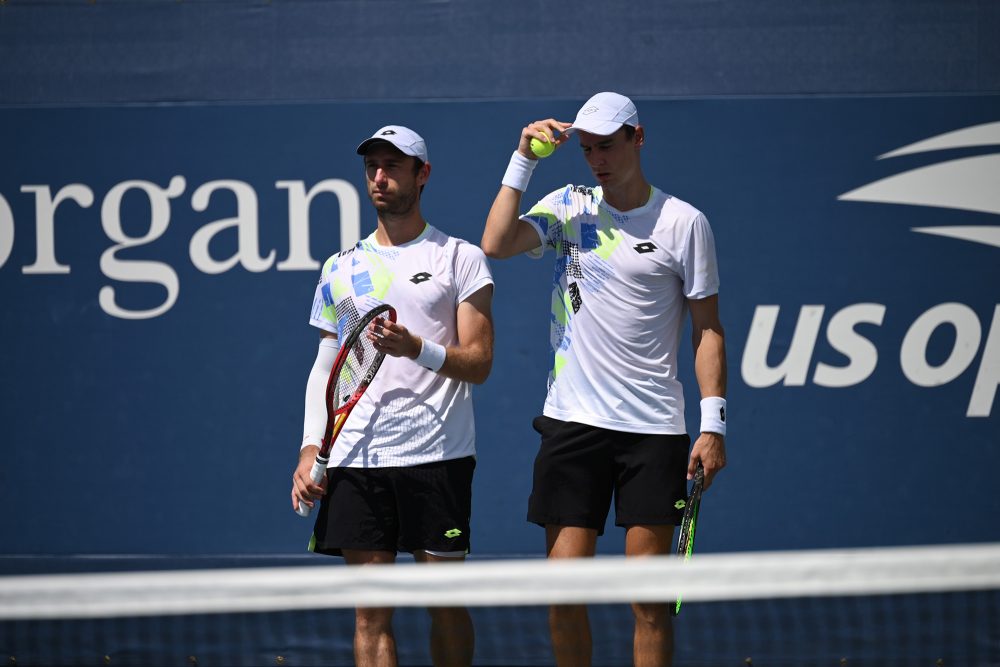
295, 304, 396, 517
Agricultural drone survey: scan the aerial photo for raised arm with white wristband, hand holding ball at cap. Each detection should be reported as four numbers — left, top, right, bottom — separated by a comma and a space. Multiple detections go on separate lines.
480, 118, 570, 259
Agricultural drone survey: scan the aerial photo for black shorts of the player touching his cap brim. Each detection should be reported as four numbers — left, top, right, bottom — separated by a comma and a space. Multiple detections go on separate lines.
528, 416, 691, 535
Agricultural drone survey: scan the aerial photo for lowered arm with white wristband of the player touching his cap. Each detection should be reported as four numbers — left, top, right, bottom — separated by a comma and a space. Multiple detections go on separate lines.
688, 294, 726, 489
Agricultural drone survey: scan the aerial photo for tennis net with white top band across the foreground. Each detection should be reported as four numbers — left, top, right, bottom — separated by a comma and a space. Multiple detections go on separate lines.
0, 544, 1000, 667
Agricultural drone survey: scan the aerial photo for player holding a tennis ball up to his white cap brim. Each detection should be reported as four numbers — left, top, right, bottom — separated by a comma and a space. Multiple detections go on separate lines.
482, 92, 726, 667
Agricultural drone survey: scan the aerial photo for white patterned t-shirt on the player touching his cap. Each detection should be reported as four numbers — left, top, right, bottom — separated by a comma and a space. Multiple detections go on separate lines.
521, 185, 719, 434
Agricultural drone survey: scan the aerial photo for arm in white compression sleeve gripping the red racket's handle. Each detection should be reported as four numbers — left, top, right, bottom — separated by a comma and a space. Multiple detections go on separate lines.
292, 331, 339, 508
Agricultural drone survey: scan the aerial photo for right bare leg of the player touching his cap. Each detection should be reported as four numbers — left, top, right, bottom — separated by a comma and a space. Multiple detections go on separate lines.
625, 526, 674, 667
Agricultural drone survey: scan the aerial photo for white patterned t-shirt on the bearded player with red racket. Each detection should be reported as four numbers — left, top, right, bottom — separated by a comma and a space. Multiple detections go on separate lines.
309, 225, 493, 468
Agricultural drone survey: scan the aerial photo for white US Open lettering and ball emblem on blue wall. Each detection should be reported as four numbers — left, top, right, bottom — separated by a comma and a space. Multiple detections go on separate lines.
741, 122, 1000, 417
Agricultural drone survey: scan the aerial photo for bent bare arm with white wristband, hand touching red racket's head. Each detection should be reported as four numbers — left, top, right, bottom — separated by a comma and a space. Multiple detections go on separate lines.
370, 284, 496, 384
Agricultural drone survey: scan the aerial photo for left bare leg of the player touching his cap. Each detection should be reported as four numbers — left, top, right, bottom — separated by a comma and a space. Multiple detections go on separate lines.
545, 526, 597, 667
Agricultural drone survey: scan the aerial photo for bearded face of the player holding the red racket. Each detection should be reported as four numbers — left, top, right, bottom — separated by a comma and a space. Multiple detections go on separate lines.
364, 143, 428, 215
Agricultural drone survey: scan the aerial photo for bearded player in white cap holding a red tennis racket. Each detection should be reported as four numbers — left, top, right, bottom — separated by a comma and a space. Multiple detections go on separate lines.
292, 126, 493, 667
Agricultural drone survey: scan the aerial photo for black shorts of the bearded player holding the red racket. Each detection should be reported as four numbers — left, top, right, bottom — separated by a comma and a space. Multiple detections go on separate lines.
312, 456, 476, 556
